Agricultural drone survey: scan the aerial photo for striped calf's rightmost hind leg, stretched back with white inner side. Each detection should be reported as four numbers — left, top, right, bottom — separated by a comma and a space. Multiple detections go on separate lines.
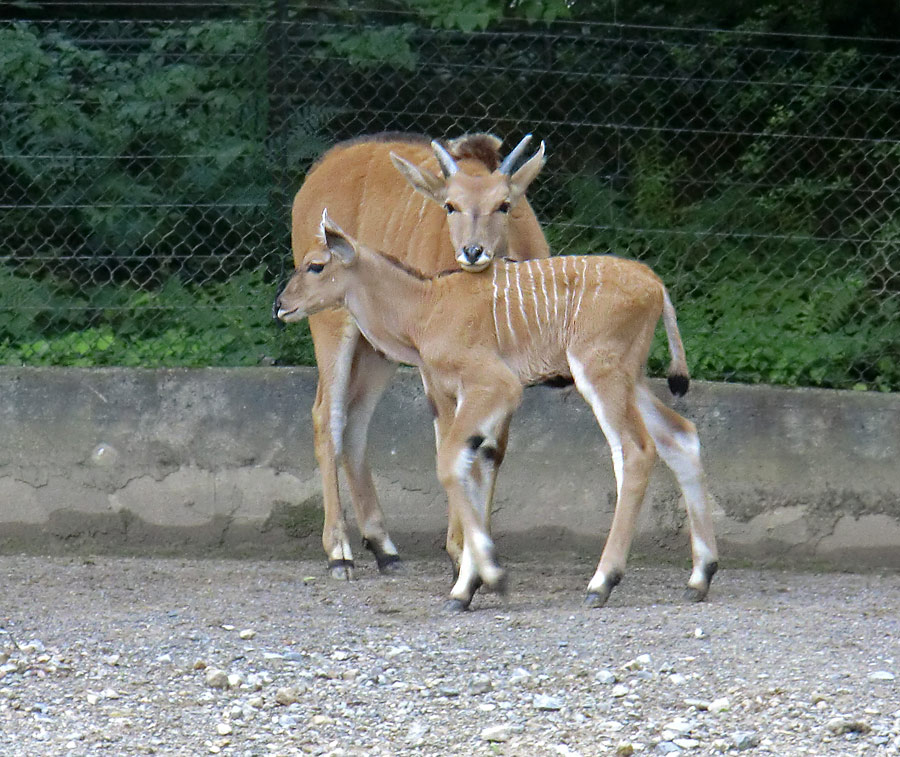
637, 384, 719, 602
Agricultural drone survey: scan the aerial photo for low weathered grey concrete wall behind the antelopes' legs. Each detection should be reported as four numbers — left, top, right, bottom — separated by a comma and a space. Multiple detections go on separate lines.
0, 368, 900, 568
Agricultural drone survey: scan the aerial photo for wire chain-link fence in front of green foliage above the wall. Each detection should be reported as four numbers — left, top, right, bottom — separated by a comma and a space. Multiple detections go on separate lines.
0, 5, 900, 390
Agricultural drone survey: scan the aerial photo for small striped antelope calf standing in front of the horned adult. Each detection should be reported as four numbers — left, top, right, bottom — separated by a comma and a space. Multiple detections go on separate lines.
275, 212, 717, 609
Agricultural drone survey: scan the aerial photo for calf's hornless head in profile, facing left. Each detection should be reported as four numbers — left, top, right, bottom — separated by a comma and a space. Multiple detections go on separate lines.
273, 210, 356, 323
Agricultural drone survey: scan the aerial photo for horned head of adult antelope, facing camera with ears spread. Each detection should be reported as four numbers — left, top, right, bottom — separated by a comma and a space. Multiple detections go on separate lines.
391, 134, 544, 272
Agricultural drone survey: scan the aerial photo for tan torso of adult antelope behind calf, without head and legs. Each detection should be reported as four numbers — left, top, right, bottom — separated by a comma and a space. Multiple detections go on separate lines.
291, 134, 549, 275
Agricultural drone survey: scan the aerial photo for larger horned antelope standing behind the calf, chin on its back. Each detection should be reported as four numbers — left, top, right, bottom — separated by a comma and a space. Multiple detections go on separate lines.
291, 133, 550, 578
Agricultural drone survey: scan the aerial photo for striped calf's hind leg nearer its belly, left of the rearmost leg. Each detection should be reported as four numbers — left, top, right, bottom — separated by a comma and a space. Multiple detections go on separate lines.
569, 356, 655, 607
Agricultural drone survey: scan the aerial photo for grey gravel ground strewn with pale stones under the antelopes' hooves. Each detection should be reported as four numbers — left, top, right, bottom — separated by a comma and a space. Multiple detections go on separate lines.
0, 556, 900, 757
